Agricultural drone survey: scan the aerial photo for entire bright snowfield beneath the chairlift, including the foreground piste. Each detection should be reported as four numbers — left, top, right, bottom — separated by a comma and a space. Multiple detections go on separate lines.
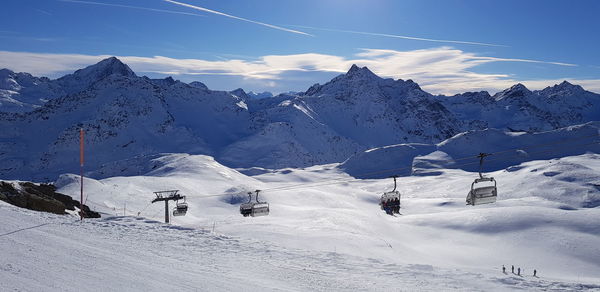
0, 153, 600, 291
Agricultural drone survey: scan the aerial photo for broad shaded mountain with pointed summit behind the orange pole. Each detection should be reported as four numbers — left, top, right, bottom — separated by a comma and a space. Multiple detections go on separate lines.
0, 58, 249, 180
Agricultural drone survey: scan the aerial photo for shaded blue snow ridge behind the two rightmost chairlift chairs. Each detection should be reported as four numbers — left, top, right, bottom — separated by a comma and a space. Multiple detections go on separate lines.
340, 122, 600, 178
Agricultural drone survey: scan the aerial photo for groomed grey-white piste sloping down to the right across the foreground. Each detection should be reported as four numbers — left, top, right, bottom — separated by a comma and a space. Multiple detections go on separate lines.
0, 204, 600, 291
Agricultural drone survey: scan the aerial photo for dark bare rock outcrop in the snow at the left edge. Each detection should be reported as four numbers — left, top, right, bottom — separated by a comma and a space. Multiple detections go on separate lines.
0, 181, 100, 218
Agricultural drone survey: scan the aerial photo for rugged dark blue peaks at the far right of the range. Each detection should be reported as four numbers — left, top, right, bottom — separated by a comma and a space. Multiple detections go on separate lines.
437, 81, 600, 132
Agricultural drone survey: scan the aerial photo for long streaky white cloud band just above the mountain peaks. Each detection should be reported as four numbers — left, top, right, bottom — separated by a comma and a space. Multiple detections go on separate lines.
0, 47, 600, 94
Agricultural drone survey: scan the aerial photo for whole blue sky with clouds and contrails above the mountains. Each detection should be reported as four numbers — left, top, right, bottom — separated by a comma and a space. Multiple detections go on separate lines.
0, 0, 600, 94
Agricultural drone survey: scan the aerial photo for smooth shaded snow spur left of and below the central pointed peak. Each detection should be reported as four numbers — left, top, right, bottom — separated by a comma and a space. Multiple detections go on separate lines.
220, 98, 363, 168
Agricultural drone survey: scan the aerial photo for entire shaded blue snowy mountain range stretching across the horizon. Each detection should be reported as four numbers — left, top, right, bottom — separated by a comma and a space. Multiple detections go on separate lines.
0, 57, 600, 180
